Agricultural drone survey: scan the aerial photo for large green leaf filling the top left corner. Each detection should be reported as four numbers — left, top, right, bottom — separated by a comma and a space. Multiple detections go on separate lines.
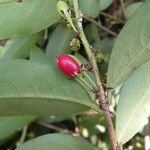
0, 0, 59, 39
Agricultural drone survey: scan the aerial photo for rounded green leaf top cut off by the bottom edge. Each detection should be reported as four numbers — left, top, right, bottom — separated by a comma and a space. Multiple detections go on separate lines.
16, 133, 98, 150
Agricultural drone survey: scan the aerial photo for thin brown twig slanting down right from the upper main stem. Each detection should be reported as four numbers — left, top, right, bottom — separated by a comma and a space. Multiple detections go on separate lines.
83, 15, 117, 36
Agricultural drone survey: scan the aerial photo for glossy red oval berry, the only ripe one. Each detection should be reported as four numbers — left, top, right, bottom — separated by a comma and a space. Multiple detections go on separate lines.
57, 54, 81, 77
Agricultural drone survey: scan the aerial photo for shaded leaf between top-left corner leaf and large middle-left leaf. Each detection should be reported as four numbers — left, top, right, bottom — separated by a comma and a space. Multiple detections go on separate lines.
2, 34, 40, 59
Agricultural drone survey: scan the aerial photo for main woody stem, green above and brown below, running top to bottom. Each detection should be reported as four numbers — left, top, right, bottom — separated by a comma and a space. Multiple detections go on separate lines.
73, 0, 119, 150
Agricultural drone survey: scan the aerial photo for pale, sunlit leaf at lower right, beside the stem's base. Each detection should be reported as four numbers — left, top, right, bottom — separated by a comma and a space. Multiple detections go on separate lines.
116, 61, 150, 144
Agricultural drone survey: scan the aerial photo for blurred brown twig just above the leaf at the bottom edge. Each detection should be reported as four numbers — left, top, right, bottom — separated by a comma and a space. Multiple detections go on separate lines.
37, 121, 78, 136
